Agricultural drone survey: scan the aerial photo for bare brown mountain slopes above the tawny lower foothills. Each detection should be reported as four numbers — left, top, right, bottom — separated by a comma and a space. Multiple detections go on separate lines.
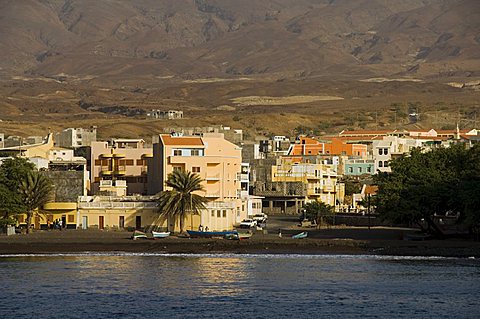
0, 0, 480, 78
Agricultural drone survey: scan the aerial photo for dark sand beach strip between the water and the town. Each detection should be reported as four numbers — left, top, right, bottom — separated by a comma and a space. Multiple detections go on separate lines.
0, 228, 480, 258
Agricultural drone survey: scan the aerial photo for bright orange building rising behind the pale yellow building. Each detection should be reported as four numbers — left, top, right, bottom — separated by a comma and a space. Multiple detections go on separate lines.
289, 137, 367, 158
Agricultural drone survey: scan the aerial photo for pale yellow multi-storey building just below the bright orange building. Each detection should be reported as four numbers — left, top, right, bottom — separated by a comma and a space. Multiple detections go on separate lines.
272, 157, 344, 206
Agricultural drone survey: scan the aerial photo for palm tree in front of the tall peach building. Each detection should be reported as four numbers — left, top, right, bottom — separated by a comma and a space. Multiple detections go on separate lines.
158, 170, 207, 233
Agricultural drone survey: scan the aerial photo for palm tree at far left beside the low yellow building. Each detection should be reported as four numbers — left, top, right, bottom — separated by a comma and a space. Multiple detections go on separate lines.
19, 171, 53, 234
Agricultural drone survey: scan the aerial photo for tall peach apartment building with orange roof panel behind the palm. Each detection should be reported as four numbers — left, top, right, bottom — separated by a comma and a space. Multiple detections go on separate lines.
148, 133, 247, 230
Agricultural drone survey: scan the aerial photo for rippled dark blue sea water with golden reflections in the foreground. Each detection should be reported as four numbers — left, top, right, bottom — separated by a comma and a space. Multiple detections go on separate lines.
0, 254, 480, 319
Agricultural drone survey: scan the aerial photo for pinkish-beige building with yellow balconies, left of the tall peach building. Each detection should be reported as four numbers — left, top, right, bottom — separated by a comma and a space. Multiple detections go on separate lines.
90, 139, 152, 195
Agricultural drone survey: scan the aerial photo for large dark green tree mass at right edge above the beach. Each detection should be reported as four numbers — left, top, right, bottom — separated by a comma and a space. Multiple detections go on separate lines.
374, 144, 480, 237
